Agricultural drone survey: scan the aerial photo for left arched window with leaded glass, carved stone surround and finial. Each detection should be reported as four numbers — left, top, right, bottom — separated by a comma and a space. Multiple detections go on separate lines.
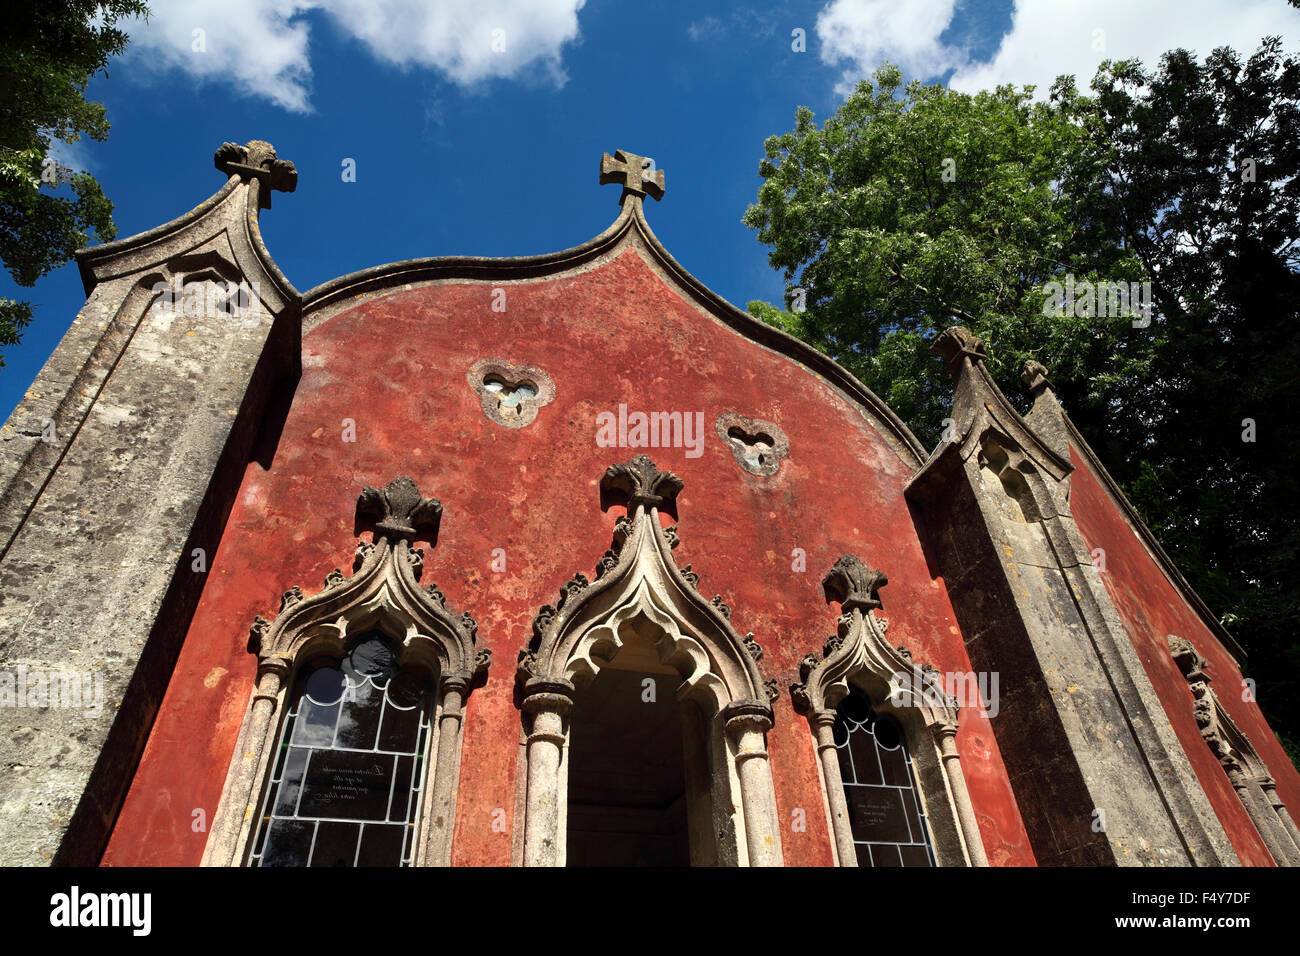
203, 477, 490, 866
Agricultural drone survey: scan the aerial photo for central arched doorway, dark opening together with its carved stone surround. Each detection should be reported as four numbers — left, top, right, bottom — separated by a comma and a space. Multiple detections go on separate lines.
517, 455, 781, 866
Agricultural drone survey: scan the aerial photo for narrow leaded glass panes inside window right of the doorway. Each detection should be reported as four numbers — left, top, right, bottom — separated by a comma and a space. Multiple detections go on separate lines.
835, 688, 935, 866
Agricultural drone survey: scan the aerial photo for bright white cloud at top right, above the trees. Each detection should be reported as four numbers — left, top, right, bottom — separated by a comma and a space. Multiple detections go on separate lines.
816, 0, 1300, 95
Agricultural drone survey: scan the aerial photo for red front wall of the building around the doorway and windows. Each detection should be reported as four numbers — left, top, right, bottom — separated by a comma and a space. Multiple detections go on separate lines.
104, 250, 1034, 865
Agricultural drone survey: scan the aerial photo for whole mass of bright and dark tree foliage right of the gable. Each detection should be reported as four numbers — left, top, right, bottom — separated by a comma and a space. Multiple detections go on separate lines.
745, 39, 1300, 752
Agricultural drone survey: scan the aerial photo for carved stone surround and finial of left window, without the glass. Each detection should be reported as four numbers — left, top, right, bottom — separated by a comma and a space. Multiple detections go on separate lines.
203, 477, 491, 866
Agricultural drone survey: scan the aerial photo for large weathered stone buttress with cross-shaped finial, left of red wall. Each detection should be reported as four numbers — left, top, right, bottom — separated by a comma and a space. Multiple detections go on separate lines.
0, 140, 302, 866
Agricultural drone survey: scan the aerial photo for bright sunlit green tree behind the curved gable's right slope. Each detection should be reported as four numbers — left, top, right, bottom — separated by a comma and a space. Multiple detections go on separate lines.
745, 66, 1151, 444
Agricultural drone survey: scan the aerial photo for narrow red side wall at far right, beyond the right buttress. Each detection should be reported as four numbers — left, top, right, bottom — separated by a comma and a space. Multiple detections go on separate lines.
1070, 449, 1300, 866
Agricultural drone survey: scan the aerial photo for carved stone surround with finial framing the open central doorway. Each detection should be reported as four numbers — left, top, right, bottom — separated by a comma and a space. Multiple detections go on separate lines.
516, 455, 781, 866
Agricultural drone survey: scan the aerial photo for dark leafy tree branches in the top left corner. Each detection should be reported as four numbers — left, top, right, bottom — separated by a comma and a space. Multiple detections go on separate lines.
0, 0, 148, 367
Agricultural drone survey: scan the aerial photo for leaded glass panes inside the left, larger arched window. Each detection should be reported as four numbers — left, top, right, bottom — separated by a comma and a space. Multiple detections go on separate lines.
250, 632, 433, 866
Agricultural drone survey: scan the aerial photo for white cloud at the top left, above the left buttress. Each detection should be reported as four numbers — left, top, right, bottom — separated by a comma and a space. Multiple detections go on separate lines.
127, 0, 585, 112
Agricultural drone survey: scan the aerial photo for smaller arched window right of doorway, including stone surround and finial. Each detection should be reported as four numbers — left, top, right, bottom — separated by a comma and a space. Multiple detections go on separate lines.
790, 554, 988, 866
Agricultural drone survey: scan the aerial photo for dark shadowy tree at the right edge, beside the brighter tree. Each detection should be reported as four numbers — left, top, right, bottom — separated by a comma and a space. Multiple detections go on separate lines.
1092, 38, 1300, 758
